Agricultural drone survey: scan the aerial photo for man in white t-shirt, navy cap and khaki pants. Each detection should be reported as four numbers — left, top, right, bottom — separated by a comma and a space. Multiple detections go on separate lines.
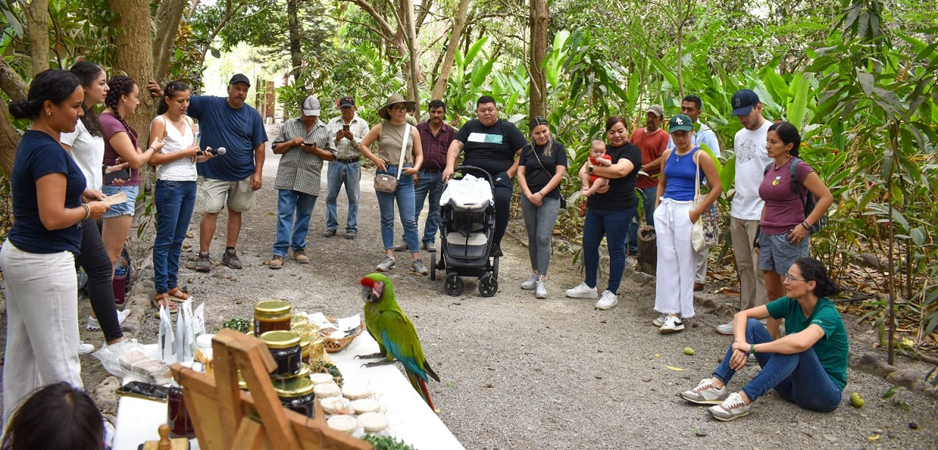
717, 89, 775, 335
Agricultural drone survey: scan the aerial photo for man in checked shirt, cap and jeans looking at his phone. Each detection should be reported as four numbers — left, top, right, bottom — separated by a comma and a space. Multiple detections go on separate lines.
270, 95, 335, 269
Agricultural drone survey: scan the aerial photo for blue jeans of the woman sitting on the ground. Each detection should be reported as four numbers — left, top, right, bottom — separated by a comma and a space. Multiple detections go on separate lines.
713, 319, 841, 412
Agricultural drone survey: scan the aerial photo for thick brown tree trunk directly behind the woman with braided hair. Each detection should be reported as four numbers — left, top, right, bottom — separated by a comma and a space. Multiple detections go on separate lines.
107, 0, 156, 146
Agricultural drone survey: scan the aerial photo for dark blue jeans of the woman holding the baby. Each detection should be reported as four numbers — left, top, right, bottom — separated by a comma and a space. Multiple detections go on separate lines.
583, 208, 635, 294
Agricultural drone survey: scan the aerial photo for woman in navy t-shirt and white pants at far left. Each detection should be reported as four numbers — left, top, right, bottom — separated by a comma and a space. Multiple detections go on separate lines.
0, 69, 108, 423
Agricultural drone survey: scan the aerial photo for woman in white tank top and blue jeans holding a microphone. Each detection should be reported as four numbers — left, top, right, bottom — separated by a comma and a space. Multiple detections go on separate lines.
150, 81, 212, 313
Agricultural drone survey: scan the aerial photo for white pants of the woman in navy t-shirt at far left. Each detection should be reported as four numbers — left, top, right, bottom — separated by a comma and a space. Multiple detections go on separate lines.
0, 240, 83, 428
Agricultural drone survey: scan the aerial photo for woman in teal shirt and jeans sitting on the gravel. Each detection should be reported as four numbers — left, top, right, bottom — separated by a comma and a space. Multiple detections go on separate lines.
681, 258, 850, 421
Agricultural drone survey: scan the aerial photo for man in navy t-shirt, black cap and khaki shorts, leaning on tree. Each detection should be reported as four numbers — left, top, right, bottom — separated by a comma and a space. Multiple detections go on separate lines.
188, 73, 267, 272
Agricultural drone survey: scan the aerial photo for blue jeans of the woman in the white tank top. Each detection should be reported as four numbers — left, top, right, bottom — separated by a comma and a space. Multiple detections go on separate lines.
153, 180, 197, 294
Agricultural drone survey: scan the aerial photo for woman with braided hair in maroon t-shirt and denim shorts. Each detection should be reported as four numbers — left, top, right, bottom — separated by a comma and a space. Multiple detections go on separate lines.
99, 75, 163, 280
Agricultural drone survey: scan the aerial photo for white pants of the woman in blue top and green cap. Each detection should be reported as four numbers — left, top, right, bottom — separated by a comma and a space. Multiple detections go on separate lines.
655, 198, 697, 319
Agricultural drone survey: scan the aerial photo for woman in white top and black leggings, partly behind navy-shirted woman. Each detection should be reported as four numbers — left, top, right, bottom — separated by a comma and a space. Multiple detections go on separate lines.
61, 61, 130, 344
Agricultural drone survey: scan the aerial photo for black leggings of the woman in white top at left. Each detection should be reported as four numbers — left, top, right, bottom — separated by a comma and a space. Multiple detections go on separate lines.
78, 219, 124, 342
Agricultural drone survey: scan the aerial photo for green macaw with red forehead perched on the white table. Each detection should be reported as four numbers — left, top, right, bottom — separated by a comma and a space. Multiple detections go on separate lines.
361, 273, 440, 410
